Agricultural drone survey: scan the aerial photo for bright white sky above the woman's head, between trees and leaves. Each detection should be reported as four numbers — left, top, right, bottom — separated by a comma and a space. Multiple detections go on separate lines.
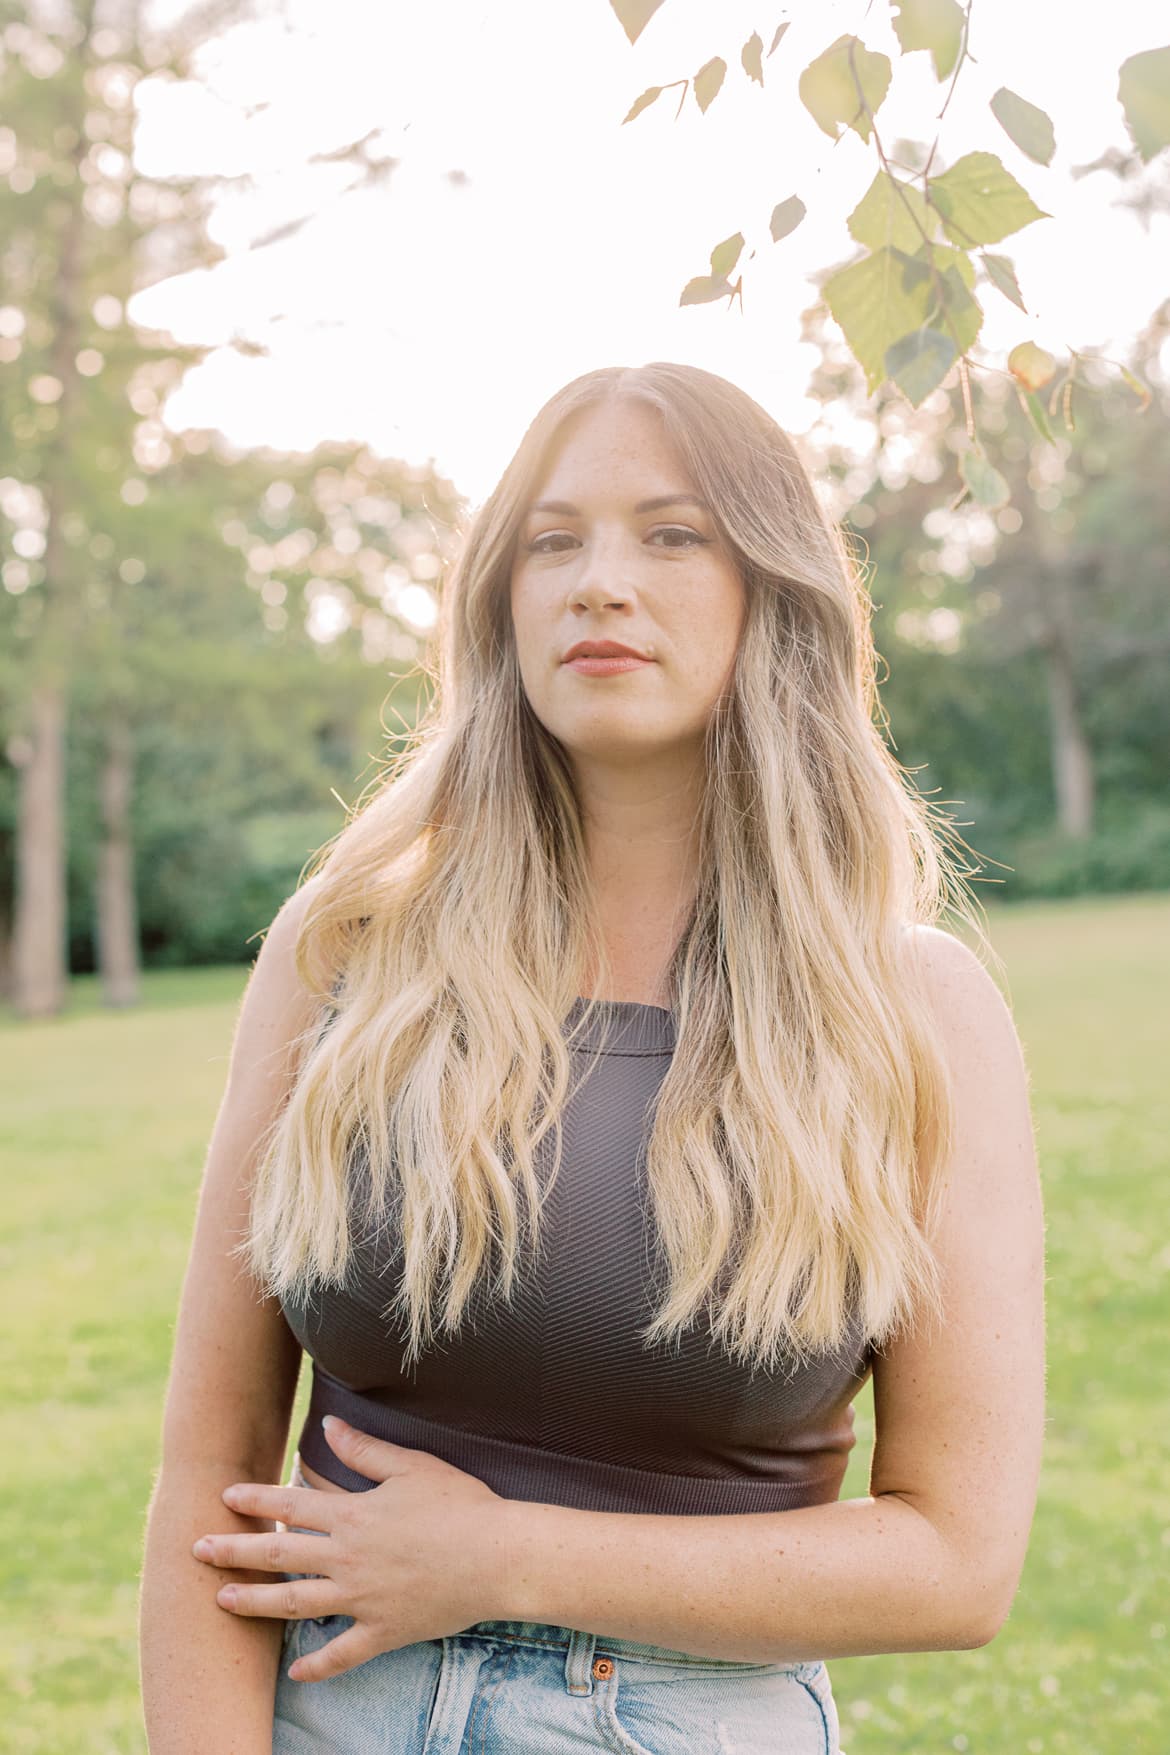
130, 0, 1170, 504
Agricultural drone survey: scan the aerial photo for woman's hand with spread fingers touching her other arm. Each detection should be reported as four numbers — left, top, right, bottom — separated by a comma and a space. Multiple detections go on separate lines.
193, 1418, 512, 1681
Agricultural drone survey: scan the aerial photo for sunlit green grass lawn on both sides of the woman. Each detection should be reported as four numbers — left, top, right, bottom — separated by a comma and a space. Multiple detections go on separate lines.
0, 895, 1170, 1755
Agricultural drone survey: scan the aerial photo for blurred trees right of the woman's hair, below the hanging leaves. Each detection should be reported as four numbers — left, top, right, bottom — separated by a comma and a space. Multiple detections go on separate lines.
803, 289, 1170, 899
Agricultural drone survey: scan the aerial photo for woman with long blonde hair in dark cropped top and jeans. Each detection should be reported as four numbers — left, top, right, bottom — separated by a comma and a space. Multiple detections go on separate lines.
140, 363, 1044, 1755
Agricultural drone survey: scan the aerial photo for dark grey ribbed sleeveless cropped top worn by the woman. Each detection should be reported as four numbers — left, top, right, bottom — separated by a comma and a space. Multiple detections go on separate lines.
282, 999, 872, 1515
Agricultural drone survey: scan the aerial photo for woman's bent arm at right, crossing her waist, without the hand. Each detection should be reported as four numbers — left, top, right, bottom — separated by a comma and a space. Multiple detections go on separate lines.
493, 928, 1045, 1662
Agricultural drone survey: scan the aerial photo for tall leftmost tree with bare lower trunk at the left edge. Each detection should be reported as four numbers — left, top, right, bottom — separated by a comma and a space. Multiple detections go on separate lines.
0, 0, 261, 1016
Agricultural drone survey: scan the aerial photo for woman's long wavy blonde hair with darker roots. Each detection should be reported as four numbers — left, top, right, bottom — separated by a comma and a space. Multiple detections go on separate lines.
237, 362, 995, 1369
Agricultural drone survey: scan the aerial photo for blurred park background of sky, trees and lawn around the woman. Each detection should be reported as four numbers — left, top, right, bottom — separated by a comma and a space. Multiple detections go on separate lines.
0, 0, 1170, 1755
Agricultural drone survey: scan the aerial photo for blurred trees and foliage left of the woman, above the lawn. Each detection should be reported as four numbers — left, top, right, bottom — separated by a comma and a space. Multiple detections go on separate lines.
0, 0, 463, 1013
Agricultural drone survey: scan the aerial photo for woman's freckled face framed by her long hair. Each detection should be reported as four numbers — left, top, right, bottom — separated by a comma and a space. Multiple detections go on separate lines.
510, 400, 746, 763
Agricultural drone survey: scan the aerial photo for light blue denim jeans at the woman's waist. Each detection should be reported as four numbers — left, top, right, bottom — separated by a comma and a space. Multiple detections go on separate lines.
272, 1457, 844, 1755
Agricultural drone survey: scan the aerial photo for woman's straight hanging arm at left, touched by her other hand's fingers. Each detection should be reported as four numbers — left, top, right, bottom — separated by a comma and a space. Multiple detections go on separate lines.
139, 879, 328, 1755
